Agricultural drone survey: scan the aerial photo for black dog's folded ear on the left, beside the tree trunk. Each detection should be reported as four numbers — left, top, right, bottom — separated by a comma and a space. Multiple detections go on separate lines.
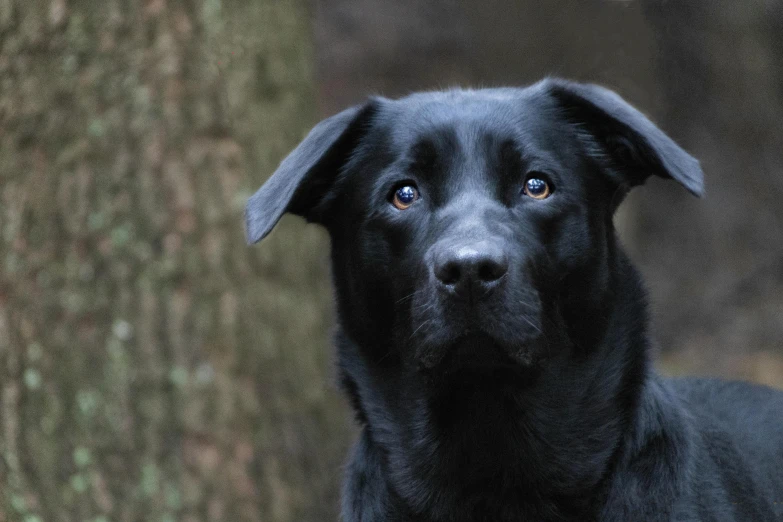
245, 101, 376, 244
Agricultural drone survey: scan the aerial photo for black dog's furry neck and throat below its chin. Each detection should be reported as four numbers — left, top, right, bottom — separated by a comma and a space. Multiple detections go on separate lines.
338, 251, 648, 520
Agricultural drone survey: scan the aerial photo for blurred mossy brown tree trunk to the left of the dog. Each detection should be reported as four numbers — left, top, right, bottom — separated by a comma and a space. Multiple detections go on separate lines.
0, 0, 350, 522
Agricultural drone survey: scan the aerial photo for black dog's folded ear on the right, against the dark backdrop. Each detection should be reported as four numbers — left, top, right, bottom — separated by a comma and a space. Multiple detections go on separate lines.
543, 79, 704, 196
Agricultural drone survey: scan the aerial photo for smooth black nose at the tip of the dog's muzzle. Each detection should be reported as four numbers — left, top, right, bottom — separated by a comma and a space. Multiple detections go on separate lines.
433, 241, 508, 293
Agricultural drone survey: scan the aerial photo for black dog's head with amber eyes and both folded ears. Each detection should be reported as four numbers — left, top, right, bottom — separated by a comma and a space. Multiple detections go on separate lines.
246, 79, 703, 380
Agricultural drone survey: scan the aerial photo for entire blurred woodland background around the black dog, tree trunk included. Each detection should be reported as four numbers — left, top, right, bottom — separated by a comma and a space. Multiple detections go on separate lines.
0, 0, 783, 522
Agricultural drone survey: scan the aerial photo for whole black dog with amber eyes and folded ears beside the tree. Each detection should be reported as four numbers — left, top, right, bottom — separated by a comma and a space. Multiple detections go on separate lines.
247, 79, 783, 522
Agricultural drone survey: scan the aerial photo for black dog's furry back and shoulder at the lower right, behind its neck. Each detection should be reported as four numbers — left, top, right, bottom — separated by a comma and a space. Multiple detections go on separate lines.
602, 377, 783, 521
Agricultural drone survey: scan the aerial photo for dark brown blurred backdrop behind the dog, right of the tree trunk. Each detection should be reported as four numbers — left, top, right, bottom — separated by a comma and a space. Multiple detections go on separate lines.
316, 0, 783, 382
